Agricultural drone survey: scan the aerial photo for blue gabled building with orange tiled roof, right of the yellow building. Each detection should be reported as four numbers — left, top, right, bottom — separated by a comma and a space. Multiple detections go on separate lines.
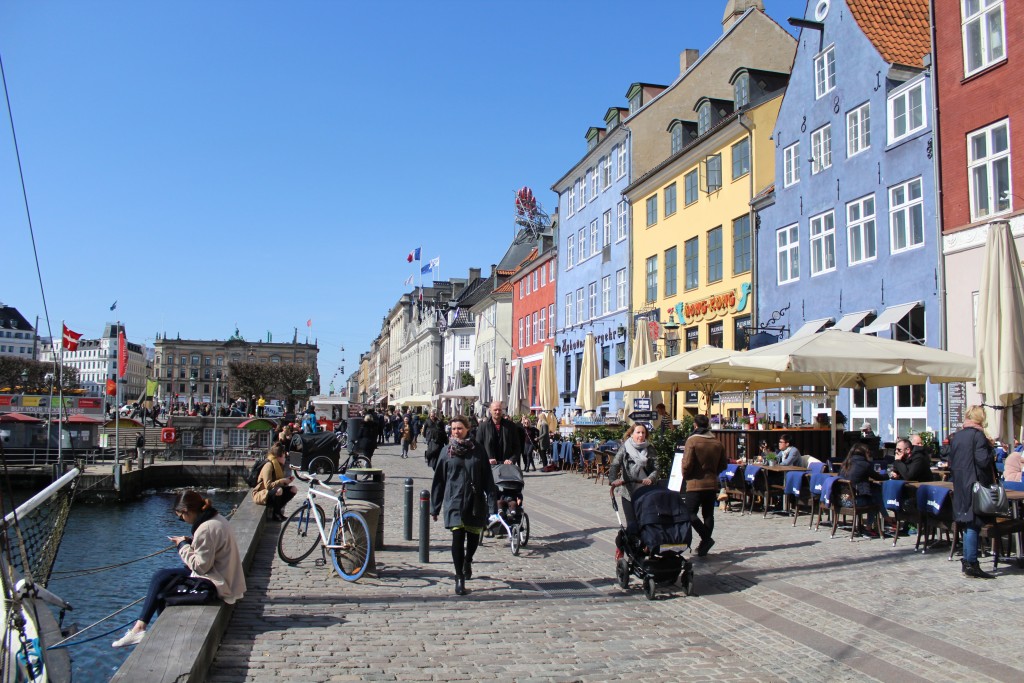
754, 0, 943, 441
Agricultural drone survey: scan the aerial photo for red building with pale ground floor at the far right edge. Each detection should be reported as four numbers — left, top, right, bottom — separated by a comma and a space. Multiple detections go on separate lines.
932, 0, 1024, 404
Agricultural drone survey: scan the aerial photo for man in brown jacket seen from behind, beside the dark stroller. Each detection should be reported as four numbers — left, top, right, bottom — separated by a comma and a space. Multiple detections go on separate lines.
683, 415, 729, 557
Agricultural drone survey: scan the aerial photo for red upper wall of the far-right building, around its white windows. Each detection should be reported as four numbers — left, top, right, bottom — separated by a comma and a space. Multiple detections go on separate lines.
934, 0, 1024, 232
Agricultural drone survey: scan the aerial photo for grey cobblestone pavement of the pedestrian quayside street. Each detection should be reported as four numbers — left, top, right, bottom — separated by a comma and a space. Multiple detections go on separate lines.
209, 446, 1024, 683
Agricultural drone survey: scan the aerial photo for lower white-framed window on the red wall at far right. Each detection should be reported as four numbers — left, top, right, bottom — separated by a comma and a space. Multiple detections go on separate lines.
967, 119, 1013, 220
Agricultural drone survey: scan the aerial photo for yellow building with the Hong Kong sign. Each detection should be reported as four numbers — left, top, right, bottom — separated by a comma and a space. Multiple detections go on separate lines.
624, 85, 788, 416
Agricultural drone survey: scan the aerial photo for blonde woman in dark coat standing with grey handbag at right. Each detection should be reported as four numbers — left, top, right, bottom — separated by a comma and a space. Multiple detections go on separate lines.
949, 405, 995, 579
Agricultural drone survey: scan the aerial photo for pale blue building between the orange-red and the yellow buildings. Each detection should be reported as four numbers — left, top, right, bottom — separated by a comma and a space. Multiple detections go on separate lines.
551, 106, 630, 415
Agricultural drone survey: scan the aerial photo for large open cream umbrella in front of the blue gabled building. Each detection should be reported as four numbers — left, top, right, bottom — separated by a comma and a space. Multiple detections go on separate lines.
694, 330, 976, 458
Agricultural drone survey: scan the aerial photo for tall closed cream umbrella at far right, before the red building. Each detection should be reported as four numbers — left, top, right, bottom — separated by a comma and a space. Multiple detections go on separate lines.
975, 220, 1024, 440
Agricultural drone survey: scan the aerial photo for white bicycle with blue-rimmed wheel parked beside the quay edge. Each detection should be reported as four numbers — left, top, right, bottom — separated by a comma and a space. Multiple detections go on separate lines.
278, 465, 373, 581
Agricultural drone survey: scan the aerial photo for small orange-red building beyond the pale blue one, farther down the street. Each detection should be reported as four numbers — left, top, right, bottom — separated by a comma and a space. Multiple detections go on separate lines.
509, 249, 557, 411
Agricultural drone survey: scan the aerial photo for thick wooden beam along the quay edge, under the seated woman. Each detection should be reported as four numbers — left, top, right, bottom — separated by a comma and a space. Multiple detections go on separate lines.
111, 495, 266, 683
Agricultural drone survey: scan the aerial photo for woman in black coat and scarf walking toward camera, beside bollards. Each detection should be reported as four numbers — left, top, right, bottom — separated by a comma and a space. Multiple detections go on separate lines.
430, 416, 498, 595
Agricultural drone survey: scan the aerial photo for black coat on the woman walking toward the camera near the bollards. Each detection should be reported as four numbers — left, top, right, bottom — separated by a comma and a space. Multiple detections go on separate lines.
430, 441, 498, 528
